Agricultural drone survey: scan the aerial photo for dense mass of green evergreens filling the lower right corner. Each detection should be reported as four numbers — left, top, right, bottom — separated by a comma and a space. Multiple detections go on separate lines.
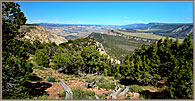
120, 35, 193, 99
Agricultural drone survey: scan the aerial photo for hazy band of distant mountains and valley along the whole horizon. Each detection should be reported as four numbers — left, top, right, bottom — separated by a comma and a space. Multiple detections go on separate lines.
27, 22, 193, 39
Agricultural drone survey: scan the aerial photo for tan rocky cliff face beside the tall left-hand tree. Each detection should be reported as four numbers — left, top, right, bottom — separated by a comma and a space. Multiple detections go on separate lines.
19, 24, 67, 45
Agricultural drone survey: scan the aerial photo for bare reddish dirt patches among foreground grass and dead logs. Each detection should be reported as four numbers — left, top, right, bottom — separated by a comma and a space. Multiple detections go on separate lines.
31, 68, 148, 99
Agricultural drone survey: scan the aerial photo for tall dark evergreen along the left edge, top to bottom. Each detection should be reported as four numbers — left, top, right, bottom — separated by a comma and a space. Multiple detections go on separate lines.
2, 2, 33, 99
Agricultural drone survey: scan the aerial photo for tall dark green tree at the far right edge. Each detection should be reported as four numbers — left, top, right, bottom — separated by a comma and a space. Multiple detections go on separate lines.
167, 35, 193, 99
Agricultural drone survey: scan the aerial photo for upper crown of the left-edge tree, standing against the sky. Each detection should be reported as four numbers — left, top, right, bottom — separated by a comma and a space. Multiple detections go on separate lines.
2, 2, 27, 43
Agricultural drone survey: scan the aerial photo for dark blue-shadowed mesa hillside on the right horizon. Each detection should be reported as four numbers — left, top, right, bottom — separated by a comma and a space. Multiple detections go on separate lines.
121, 23, 193, 38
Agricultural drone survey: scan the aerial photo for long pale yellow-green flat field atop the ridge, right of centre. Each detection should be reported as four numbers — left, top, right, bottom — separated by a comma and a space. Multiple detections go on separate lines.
114, 30, 183, 42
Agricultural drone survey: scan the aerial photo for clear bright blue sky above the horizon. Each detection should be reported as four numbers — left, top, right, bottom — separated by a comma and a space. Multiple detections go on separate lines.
18, 2, 193, 25
